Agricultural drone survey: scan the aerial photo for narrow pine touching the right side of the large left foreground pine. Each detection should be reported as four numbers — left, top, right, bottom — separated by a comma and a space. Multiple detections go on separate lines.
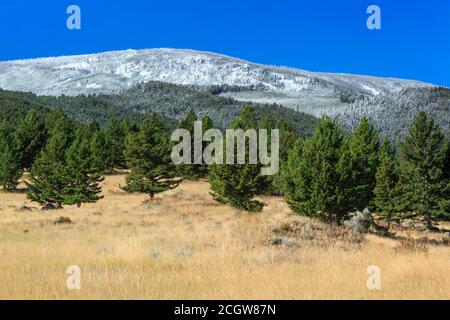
63, 129, 103, 207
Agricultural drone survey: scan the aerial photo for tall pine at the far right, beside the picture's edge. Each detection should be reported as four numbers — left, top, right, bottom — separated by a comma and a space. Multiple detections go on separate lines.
399, 112, 449, 229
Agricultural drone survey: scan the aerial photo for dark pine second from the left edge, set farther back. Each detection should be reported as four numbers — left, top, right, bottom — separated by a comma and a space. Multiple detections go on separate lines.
16, 109, 47, 169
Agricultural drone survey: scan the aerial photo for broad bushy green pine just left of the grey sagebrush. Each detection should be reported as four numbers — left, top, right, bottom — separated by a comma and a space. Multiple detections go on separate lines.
283, 117, 347, 222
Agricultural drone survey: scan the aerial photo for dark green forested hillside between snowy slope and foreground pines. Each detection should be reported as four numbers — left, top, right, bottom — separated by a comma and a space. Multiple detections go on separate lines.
0, 82, 317, 136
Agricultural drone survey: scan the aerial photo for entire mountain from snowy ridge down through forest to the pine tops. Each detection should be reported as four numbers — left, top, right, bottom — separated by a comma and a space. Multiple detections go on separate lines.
0, 49, 450, 140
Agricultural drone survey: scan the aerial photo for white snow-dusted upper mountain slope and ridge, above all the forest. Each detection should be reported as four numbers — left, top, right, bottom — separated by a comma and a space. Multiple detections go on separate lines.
0, 49, 430, 98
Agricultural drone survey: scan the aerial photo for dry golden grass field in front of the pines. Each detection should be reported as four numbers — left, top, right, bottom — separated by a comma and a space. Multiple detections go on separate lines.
0, 176, 450, 299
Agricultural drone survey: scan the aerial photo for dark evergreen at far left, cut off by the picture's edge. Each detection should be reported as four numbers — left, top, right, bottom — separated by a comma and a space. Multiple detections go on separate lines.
0, 123, 22, 191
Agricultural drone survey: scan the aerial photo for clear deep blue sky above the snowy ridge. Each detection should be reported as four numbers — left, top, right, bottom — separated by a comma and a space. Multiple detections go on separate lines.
0, 0, 450, 87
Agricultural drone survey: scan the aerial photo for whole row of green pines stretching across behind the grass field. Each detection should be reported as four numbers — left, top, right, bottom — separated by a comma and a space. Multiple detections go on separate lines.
0, 107, 450, 228
